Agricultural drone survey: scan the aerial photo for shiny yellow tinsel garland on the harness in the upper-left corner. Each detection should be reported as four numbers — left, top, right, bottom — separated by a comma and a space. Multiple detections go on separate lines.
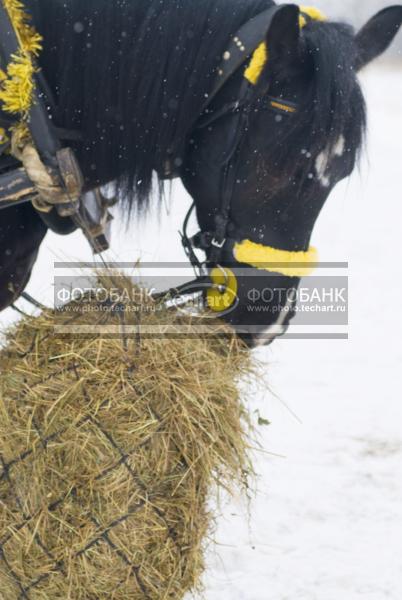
0, 0, 42, 118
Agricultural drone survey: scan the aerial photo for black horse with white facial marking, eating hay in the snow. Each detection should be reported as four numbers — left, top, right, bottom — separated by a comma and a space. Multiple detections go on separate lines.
0, 0, 402, 343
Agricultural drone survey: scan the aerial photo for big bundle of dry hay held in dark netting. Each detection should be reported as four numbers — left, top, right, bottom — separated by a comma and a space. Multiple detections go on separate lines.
0, 278, 251, 600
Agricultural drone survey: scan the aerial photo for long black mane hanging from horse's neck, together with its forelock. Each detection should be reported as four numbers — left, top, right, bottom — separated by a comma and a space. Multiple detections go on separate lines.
27, 0, 364, 207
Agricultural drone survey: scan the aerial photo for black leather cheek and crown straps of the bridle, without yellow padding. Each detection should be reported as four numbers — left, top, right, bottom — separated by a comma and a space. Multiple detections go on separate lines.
163, 6, 308, 294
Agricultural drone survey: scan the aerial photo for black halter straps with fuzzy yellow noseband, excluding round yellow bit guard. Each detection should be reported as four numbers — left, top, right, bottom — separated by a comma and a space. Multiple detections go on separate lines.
187, 5, 325, 277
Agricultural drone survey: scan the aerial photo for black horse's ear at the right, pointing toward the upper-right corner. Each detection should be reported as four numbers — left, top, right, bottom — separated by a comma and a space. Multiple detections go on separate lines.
356, 5, 402, 71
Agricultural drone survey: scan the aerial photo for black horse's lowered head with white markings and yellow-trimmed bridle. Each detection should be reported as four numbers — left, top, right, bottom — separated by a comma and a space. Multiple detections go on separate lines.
182, 4, 402, 345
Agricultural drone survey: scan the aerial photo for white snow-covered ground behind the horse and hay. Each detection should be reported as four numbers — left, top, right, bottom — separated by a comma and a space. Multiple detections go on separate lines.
0, 64, 402, 600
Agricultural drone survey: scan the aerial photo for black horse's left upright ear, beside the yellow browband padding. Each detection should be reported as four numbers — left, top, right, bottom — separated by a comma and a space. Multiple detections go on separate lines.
266, 4, 300, 66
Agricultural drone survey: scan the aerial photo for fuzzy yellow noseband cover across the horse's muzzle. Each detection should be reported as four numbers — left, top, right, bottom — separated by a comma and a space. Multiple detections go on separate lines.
233, 240, 318, 277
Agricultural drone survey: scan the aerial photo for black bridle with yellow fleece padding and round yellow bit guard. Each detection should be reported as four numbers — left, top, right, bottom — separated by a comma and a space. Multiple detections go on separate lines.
182, 6, 325, 332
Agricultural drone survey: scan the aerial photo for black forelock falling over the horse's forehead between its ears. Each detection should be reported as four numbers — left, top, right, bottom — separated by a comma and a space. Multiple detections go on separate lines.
258, 21, 366, 190
